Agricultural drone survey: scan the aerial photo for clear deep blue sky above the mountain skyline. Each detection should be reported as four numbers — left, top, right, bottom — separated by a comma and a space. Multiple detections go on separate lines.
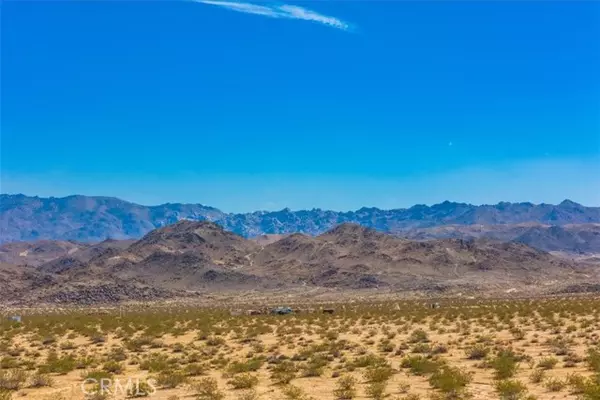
0, 1, 600, 211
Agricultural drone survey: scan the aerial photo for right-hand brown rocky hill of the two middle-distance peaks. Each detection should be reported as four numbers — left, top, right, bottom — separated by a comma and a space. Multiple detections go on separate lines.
256, 224, 574, 291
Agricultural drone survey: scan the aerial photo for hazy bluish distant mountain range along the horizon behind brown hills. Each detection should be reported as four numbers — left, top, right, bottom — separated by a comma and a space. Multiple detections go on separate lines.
0, 194, 600, 253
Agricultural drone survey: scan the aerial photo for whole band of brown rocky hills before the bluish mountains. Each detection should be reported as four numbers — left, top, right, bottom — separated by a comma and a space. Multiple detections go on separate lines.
0, 220, 598, 303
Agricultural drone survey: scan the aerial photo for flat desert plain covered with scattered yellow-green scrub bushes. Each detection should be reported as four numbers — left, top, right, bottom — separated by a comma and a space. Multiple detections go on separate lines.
0, 298, 600, 400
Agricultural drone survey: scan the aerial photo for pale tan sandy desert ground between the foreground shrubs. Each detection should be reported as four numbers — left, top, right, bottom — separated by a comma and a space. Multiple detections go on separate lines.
0, 298, 600, 400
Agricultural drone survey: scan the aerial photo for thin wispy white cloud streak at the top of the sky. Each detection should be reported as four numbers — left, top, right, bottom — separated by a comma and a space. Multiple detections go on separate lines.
194, 0, 350, 30
